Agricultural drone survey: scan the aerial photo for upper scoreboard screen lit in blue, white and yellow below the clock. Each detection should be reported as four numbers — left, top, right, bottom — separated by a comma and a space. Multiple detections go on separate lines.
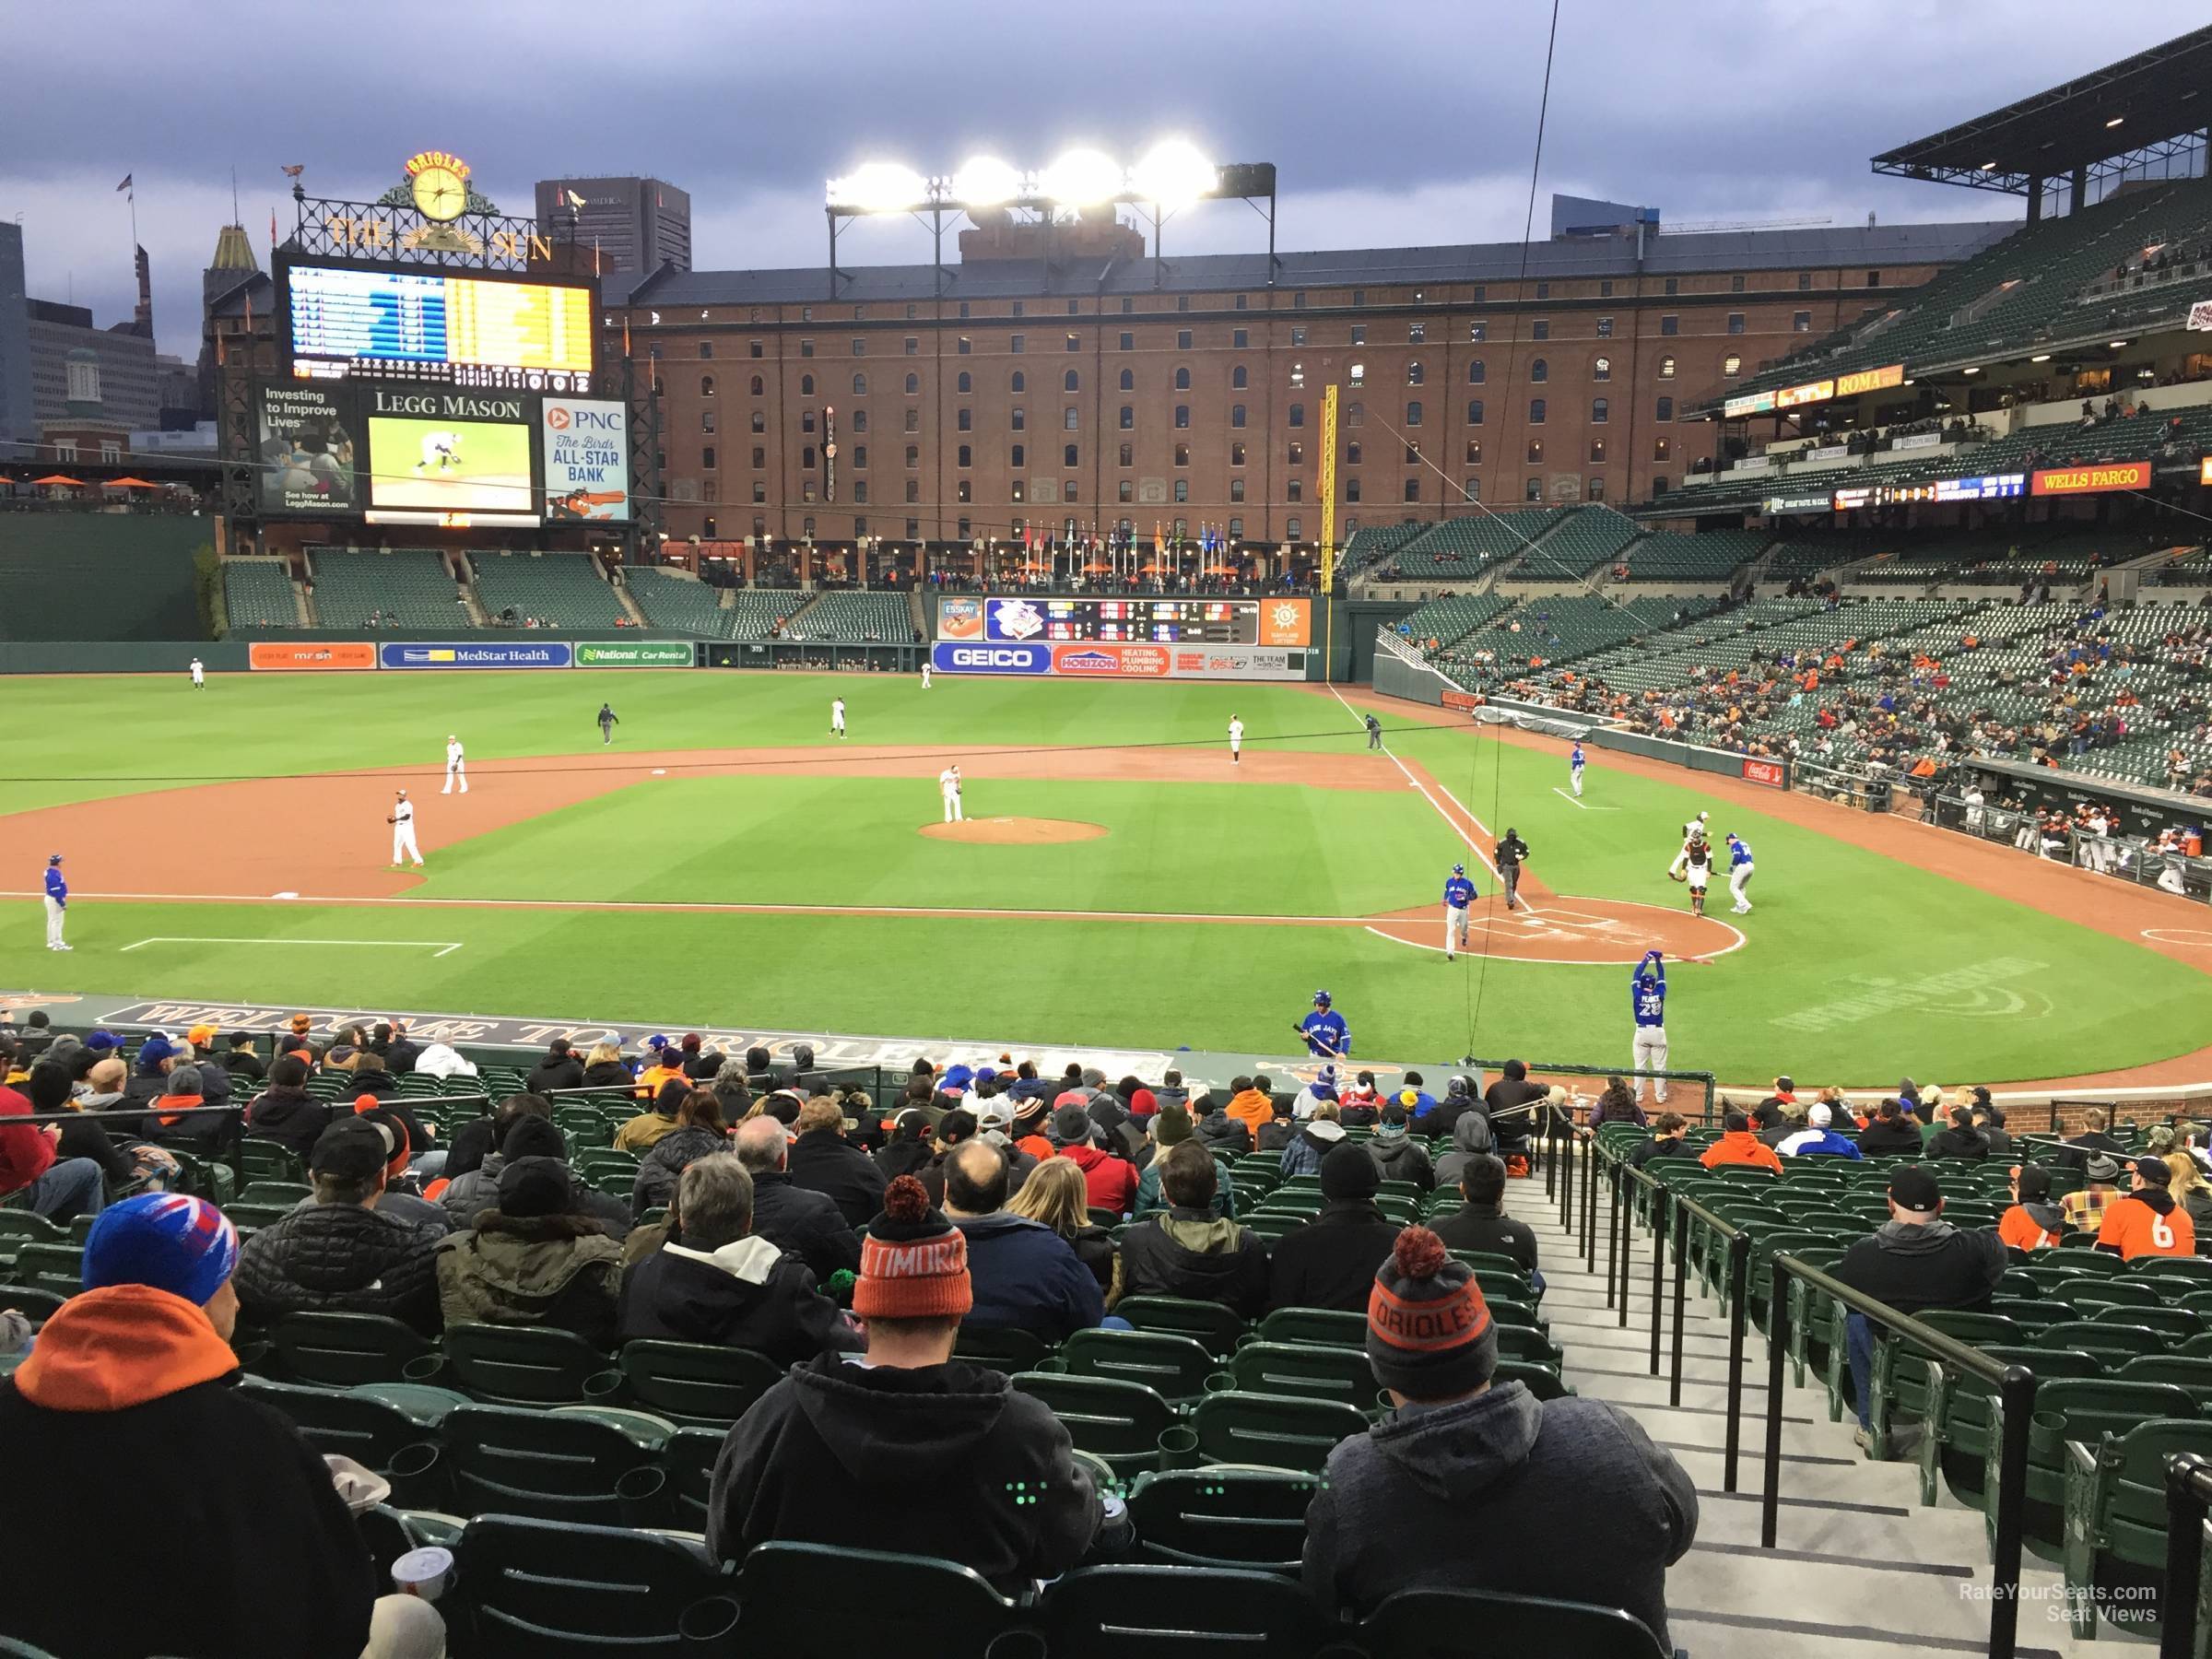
288, 265, 593, 392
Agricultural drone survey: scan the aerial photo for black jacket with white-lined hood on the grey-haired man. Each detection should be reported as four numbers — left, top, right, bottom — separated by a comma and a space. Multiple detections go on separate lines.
615, 1234, 861, 1365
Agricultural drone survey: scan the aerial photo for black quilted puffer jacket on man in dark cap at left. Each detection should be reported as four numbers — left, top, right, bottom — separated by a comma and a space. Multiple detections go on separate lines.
234, 1204, 442, 1336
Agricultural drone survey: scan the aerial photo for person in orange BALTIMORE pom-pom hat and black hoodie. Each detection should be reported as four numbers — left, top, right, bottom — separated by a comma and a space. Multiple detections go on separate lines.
703, 1176, 1119, 1593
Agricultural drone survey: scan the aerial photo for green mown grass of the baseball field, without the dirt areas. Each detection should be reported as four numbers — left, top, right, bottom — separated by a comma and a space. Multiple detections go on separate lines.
0, 673, 2212, 1084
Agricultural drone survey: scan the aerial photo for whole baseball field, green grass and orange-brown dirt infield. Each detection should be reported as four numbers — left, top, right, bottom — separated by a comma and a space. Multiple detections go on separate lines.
0, 670, 2212, 1086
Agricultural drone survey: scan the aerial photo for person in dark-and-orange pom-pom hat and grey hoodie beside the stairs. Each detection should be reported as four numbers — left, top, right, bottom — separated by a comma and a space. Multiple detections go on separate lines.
1305, 1228, 1697, 1650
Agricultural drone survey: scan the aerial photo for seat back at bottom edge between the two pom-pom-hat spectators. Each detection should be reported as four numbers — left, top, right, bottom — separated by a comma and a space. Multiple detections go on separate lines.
1038, 1564, 1332, 1659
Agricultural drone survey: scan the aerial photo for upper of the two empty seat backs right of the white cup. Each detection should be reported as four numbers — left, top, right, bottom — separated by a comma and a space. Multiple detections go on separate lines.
438, 1405, 668, 1526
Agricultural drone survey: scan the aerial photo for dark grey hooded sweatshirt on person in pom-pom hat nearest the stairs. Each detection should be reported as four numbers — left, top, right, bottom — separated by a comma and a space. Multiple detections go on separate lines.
1305, 1382, 1697, 1650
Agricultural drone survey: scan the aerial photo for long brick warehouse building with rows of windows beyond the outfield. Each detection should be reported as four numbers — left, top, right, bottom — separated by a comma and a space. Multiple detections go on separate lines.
604, 204, 2013, 561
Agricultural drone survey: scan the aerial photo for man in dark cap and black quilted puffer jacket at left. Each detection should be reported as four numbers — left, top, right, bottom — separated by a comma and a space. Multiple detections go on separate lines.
239, 1117, 442, 1336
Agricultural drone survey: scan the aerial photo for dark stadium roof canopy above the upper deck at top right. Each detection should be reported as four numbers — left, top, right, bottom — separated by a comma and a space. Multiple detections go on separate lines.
1874, 27, 2212, 194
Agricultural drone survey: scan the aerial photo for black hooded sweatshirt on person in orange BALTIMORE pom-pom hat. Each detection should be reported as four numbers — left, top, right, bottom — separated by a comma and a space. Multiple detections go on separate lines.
706, 1356, 1101, 1593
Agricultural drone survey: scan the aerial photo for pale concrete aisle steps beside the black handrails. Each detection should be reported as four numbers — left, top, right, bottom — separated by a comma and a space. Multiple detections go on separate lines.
1506, 1168, 2105, 1659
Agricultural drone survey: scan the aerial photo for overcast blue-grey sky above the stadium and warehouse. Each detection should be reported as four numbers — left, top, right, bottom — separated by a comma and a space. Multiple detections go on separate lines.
0, 0, 2203, 356
